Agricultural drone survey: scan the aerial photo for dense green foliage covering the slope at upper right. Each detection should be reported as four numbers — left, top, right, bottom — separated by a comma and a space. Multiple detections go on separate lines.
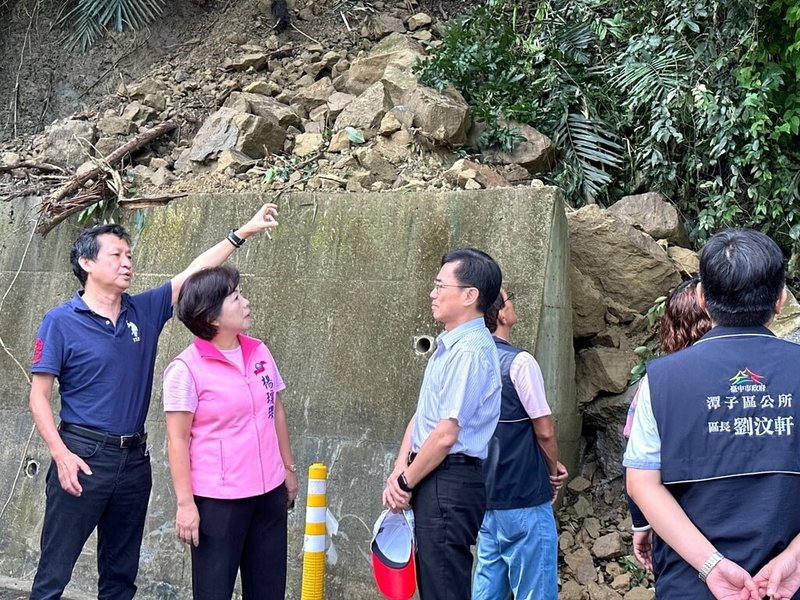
417, 0, 800, 263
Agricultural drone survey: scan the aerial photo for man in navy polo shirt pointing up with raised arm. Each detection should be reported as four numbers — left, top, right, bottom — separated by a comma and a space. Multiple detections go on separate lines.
30, 204, 277, 600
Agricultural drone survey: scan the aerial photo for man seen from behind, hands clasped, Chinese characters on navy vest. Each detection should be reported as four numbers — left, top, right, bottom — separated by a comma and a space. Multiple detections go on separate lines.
624, 229, 800, 600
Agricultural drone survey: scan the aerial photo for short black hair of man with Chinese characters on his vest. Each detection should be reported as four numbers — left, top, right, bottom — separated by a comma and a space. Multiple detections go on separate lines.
700, 229, 785, 327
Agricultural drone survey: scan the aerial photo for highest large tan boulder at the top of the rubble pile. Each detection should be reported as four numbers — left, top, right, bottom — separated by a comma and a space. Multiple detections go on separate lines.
344, 33, 425, 103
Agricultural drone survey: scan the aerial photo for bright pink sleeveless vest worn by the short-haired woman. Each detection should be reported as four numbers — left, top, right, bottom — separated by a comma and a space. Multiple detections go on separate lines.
175, 335, 286, 499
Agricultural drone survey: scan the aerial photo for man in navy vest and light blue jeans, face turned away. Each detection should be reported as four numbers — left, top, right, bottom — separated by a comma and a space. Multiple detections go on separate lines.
472, 289, 568, 600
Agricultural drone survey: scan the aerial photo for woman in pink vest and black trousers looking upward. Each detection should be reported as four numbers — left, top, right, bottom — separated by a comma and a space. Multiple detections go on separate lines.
164, 266, 297, 600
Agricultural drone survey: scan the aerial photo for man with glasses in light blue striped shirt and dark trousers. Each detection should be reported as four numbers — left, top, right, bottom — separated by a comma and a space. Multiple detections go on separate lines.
383, 248, 502, 600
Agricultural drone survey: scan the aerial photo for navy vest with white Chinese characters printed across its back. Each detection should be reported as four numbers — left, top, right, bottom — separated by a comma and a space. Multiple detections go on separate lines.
647, 327, 800, 600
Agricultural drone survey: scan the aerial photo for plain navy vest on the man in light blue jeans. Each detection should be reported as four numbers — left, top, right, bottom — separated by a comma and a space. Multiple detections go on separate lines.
483, 337, 552, 510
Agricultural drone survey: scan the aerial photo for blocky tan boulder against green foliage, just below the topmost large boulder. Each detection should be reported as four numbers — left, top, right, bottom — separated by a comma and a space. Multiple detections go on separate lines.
401, 86, 470, 146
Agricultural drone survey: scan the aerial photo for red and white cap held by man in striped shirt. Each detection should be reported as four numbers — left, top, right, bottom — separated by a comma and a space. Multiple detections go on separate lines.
371, 509, 417, 600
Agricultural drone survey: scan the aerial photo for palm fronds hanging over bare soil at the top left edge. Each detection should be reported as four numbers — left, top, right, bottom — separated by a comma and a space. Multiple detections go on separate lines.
57, 0, 164, 52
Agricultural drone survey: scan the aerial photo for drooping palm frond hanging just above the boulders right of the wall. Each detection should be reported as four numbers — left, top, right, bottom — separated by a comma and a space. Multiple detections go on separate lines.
556, 112, 624, 200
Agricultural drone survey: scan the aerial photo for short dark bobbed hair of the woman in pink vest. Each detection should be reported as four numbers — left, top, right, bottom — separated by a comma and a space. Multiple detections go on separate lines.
178, 265, 239, 341
